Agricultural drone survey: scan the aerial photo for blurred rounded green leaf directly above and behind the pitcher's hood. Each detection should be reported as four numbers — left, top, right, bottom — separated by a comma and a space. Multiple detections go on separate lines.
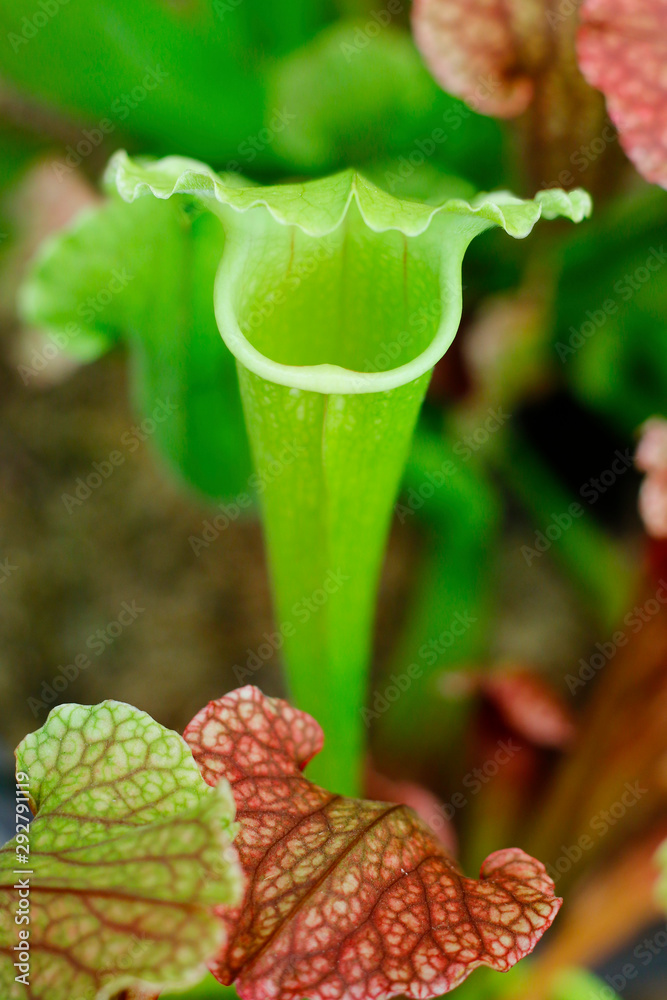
269, 19, 504, 188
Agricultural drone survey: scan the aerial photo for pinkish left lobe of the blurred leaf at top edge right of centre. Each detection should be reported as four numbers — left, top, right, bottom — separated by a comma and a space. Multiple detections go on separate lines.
412, 0, 544, 118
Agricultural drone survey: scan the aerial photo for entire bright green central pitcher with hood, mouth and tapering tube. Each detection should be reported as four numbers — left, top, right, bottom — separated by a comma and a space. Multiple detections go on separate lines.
112, 154, 590, 794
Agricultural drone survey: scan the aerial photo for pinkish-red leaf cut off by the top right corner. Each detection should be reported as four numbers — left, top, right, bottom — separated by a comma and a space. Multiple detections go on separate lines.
578, 0, 667, 187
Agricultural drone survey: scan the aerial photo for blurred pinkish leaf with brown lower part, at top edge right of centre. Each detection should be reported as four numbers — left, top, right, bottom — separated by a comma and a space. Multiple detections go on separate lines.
412, 0, 617, 190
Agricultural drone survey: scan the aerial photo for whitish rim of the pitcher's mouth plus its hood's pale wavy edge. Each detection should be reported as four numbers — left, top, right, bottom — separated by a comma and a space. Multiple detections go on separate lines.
106, 150, 592, 395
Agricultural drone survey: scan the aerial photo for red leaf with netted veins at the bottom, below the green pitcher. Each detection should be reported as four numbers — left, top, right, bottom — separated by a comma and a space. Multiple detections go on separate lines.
185, 687, 561, 1000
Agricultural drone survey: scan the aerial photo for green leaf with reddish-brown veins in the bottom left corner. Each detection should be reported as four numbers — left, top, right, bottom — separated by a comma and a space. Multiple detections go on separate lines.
0, 701, 241, 1000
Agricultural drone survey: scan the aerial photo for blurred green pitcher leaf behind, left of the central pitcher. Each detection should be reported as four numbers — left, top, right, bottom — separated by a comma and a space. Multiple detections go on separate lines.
22, 190, 251, 499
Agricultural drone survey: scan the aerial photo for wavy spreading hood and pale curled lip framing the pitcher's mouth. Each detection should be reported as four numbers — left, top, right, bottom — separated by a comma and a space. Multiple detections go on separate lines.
107, 151, 592, 395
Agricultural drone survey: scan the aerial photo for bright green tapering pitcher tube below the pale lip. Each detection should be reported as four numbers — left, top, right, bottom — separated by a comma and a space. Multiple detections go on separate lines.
239, 368, 428, 789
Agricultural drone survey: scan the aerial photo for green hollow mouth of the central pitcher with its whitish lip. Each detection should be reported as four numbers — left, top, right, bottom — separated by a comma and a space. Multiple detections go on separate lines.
215, 206, 462, 393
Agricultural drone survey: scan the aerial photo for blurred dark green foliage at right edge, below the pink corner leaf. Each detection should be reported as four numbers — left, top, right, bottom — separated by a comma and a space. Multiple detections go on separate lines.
553, 188, 667, 433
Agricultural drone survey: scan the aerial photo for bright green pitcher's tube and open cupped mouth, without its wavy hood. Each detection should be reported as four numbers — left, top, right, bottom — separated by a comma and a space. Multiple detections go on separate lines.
216, 206, 460, 794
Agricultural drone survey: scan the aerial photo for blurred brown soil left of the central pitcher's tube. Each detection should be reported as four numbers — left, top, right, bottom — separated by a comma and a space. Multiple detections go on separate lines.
0, 353, 418, 746
